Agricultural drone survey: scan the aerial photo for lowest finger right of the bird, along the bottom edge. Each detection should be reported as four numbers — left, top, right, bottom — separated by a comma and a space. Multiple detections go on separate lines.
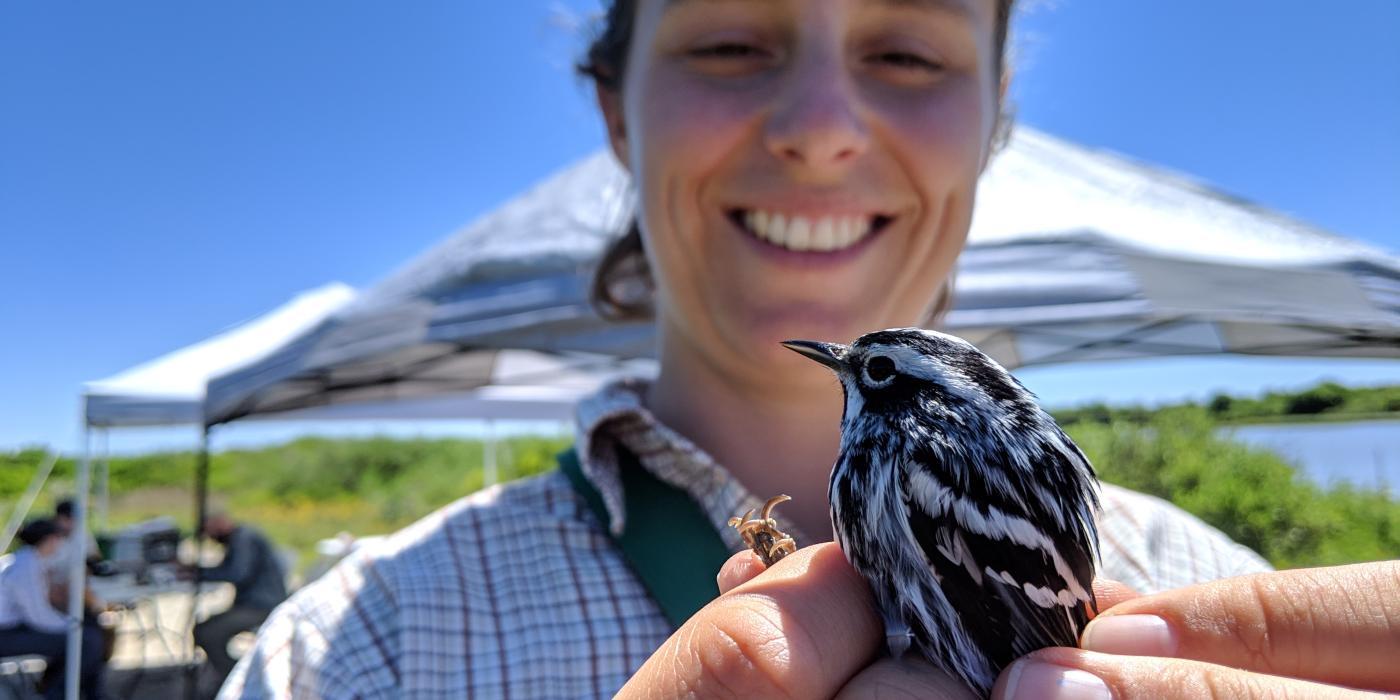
991, 648, 1376, 700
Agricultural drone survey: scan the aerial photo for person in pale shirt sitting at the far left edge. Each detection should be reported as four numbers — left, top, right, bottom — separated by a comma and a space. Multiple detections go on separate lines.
0, 519, 105, 700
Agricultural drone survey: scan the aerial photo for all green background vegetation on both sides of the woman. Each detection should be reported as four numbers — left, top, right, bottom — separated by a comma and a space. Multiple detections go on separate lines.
0, 384, 1400, 567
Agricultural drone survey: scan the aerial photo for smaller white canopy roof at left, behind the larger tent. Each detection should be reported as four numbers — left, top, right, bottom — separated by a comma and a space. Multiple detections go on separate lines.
83, 283, 354, 427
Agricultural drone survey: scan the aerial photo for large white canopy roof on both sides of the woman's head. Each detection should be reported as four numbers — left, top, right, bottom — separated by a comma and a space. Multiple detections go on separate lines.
206, 127, 1400, 424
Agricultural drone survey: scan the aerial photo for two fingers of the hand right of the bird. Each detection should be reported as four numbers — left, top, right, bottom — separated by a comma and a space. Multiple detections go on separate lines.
993, 561, 1400, 700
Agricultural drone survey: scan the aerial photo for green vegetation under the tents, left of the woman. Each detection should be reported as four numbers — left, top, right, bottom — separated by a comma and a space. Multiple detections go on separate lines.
0, 437, 570, 566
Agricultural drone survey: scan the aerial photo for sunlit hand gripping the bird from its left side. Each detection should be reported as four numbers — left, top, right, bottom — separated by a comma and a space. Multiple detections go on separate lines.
619, 545, 883, 699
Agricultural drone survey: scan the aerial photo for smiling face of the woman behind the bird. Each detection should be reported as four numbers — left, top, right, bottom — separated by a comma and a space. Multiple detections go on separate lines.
601, 0, 998, 375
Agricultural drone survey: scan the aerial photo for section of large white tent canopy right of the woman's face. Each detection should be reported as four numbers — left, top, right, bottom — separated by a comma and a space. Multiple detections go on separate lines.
945, 129, 1400, 367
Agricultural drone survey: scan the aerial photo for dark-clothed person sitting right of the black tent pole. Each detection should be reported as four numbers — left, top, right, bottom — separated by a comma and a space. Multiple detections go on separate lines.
189, 512, 287, 683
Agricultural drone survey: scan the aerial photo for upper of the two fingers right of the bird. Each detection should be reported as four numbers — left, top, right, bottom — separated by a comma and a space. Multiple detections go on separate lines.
1081, 561, 1400, 692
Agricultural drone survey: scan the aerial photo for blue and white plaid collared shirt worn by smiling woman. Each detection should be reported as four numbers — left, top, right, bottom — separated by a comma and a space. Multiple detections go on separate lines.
220, 381, 1268, 699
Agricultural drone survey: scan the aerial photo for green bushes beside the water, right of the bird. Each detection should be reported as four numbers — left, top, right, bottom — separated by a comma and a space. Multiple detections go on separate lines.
1054, 382, 1400, 567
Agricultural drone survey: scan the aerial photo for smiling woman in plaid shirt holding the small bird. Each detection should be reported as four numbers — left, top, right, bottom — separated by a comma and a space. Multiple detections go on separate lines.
224, 0, 1400, 697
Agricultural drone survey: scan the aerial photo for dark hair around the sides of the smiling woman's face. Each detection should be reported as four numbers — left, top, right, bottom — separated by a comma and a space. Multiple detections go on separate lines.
577, 0, 1016, 322
